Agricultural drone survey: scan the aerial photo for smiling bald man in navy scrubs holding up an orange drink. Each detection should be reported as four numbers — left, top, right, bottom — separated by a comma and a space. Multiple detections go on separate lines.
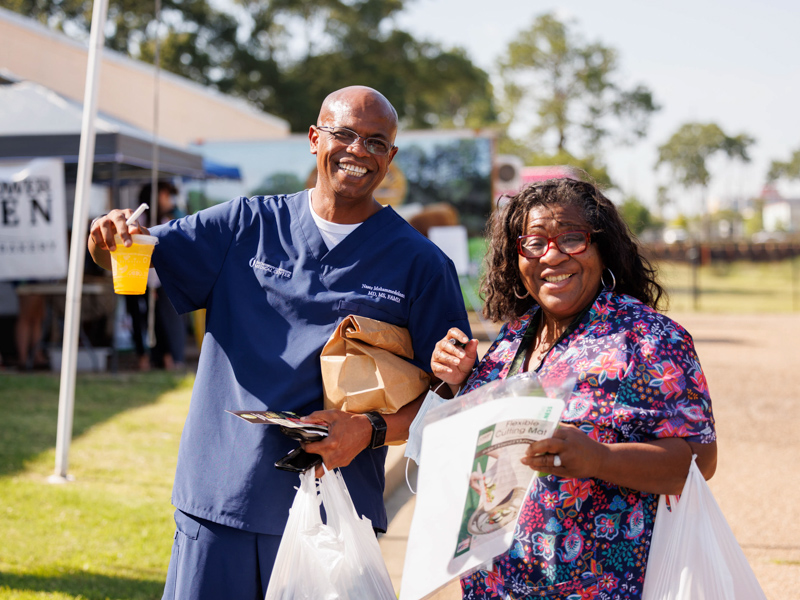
89, 86, 469, 600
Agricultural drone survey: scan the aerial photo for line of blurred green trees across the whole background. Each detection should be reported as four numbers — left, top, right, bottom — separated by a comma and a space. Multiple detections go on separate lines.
6, 0, 800, 226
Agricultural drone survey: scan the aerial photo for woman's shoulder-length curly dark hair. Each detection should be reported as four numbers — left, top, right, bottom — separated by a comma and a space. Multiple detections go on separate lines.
481, 179, 667, 321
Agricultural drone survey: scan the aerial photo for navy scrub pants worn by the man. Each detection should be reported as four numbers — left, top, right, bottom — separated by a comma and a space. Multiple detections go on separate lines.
163, 510, 281, 600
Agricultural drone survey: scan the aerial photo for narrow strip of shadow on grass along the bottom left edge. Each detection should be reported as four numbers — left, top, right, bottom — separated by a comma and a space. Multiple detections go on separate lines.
0, 572, 164, 600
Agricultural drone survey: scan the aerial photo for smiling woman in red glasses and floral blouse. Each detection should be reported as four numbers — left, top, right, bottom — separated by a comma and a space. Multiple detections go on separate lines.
432, 179, 717, 600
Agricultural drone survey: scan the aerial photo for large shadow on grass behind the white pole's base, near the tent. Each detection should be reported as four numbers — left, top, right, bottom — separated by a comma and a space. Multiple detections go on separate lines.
0, 371, 187, 477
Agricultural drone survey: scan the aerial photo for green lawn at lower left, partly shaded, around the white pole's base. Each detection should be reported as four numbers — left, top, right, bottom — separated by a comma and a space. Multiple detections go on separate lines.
0, 372, 193, 600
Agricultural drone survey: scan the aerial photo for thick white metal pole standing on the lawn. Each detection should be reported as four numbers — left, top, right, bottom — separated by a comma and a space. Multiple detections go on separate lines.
49, 0, 108, 483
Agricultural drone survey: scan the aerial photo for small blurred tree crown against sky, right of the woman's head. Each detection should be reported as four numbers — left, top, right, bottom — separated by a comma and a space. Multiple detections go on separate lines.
656, 123, 755, 188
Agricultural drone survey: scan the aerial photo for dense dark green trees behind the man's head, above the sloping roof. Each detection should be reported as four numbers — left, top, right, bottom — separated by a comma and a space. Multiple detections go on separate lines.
0, 0, 496, 131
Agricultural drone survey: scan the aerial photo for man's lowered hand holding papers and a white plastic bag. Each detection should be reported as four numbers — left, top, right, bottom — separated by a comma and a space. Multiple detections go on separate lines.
302, 410, 372, 477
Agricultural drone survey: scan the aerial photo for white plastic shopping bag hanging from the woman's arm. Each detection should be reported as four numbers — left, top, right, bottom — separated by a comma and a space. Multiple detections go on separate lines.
642, 455, 766, 600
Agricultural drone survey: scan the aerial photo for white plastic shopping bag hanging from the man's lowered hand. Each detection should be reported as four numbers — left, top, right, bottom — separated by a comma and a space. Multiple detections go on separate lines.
265, 469, 396, 600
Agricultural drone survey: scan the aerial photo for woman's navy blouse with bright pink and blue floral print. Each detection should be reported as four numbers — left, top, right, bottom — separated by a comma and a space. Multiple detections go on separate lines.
461, 291, 716, 600
